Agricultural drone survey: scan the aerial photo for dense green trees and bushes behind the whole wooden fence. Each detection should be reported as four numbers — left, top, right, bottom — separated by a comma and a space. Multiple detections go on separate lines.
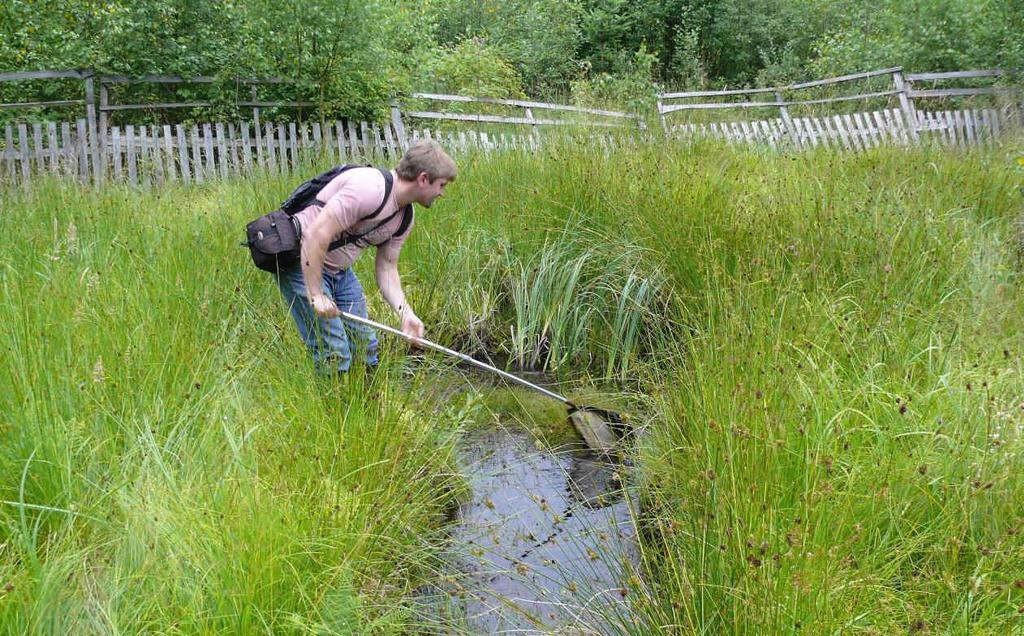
0, 0, 1024, 123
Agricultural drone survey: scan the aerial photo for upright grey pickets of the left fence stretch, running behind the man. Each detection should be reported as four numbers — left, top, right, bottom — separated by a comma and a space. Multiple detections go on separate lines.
0, 119, 561, 186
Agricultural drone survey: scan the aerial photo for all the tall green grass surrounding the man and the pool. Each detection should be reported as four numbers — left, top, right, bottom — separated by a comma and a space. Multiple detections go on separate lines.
0, 134, 1024, 634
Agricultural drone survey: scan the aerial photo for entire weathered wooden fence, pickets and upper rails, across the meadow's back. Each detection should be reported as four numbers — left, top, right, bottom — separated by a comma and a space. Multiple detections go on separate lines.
0, 68, 1024, 188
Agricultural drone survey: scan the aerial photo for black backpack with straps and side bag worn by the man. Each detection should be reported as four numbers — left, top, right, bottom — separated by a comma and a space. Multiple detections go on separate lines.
242, 164, 413, 272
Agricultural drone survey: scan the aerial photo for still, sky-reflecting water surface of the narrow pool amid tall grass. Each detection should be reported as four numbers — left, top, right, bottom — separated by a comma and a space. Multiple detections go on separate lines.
420, 423, 638, 634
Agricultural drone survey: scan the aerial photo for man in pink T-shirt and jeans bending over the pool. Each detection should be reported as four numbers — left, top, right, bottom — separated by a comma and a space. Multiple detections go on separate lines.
278, 140, 457, 374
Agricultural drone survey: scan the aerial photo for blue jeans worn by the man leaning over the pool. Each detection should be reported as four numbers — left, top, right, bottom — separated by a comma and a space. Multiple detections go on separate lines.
276, 267, 378, 375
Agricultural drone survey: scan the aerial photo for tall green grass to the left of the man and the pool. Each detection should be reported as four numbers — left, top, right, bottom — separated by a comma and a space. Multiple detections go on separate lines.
0, 176, 457, 633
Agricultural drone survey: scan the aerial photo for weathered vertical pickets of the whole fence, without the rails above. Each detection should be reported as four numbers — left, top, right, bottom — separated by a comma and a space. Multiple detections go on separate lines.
0, 109, 1021, 187
